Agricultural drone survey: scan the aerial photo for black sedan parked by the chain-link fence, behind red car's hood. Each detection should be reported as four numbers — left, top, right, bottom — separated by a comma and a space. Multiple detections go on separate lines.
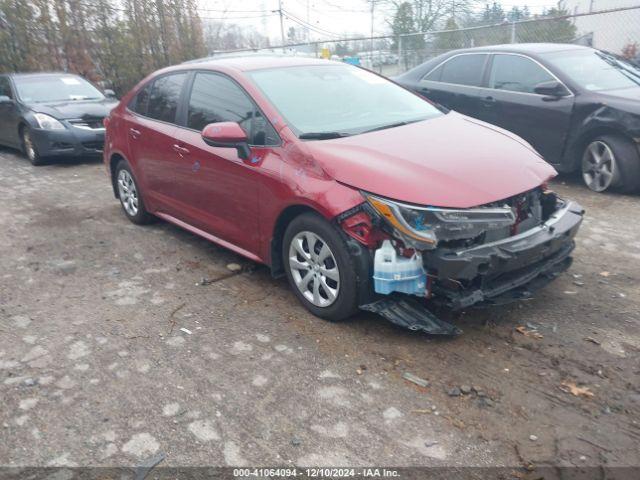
395, 44, 640, 192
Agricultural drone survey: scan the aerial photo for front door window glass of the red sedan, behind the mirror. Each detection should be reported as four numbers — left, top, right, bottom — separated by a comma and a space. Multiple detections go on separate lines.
187, 73, 280, 145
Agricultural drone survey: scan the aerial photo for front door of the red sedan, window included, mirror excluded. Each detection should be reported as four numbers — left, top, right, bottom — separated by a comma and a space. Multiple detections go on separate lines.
172, 72, 279, 253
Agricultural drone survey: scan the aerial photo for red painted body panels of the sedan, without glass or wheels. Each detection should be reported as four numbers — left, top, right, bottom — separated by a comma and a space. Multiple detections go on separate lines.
104, 58, 555, 263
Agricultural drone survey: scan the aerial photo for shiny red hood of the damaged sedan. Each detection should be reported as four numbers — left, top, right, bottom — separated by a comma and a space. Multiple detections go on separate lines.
306, 112, 556, 208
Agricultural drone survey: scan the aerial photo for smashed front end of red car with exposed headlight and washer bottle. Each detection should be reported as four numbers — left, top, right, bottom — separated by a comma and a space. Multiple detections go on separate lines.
340, 186, 584, 335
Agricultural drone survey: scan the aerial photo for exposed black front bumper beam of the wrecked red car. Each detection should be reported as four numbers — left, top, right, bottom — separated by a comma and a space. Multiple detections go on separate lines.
423, 201, 584, 310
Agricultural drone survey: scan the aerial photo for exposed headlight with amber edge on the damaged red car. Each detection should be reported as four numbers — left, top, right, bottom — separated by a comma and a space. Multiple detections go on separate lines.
365, 194, 516, 249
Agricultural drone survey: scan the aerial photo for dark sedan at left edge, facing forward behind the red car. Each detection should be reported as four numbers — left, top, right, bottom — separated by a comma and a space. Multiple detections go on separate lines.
0, 73, 117, 165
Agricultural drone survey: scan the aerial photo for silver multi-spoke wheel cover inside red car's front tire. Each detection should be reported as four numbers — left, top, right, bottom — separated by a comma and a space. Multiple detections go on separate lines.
289, 231, 340, 307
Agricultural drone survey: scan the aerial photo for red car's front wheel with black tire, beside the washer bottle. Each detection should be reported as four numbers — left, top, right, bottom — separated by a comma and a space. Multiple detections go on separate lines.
282, 213, 359, 322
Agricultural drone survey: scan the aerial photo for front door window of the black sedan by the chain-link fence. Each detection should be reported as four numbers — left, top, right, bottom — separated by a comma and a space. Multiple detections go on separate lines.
489, 54, 555, 93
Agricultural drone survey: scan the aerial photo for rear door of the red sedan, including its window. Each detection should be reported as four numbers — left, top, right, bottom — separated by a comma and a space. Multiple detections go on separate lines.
127, 72, 189, 218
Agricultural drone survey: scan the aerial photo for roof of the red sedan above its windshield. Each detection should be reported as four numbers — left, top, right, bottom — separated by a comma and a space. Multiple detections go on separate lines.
181, 55, 345, 71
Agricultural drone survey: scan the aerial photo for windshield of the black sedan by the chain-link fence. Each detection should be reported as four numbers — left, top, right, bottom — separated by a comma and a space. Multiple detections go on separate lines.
545, 50, 640, 91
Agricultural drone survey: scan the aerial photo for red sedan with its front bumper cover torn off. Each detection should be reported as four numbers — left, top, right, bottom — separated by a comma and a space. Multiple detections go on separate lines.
104, 57, 583, 334
